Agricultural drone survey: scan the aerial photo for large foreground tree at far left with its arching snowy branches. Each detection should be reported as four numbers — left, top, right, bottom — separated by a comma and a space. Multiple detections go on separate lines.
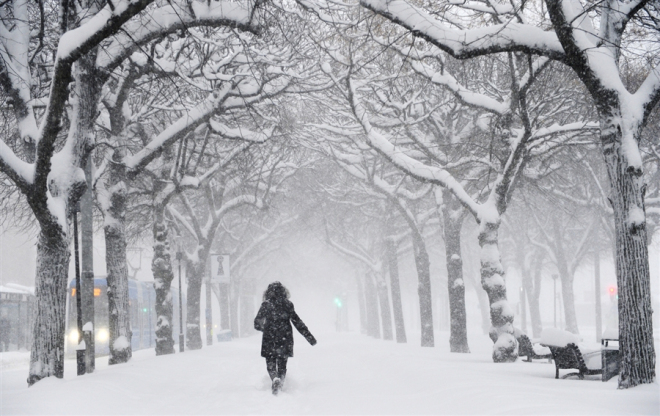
0, 0, 256, 385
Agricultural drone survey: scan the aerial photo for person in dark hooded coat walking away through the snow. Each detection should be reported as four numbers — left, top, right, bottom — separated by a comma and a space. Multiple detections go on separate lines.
254, 282, 316, 394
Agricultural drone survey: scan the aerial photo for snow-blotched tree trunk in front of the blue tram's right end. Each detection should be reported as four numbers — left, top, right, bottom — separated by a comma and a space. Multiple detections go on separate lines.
151, 204, 174, 355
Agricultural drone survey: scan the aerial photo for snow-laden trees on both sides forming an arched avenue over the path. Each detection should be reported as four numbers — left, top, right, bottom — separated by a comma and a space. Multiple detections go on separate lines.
0, 0, 660, 388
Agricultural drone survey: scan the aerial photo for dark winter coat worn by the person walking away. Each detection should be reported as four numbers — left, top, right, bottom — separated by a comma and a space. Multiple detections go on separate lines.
254, 290, 316, 357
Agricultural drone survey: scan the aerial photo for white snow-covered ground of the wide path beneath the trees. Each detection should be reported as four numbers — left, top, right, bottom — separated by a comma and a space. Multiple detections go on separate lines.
0, 333, 660, 415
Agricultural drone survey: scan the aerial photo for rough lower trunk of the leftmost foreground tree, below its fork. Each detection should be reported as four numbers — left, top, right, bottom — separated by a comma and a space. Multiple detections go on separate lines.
27, 226, 71, 386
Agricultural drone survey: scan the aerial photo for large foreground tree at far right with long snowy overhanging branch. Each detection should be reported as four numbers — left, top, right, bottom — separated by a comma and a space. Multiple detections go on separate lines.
360, 0, 660, 388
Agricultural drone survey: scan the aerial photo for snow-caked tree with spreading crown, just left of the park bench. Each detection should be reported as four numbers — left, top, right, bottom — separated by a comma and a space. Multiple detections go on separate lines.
310, 14, 586, 361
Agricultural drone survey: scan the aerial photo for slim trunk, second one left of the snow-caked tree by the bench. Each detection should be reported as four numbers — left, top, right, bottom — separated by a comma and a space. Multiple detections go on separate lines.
413, 230, 435, 347
